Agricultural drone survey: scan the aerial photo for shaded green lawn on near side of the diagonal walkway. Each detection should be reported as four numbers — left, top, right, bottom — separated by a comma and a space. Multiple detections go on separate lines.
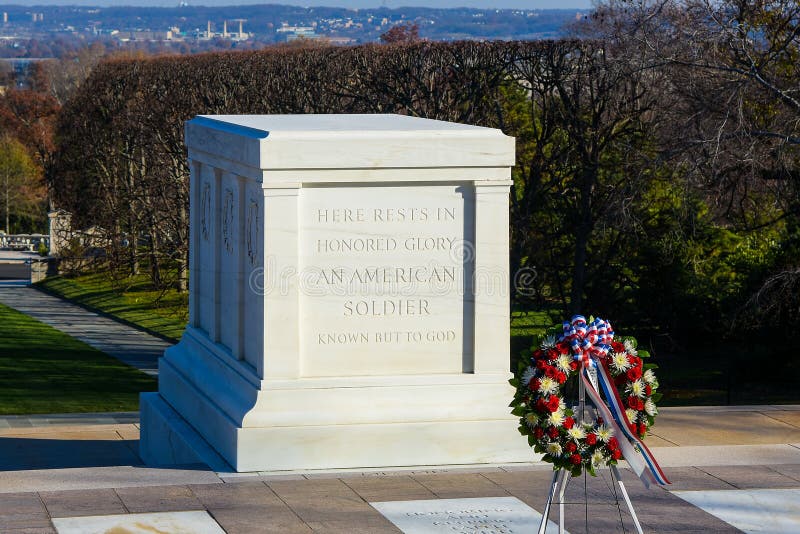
0, 304, 158, 415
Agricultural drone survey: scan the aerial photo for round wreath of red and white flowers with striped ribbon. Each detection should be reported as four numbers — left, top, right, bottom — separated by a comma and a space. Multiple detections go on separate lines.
510, 315, 668, 484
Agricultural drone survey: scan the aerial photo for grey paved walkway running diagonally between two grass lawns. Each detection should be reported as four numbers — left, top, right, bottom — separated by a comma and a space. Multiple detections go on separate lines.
0, 282, 170, 375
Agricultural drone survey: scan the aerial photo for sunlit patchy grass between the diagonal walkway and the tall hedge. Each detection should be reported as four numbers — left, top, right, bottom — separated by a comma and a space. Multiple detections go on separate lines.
36, 272, 189, 341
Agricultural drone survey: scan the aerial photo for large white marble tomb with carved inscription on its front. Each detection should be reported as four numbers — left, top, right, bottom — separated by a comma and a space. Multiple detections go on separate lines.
140, 115, 533, 471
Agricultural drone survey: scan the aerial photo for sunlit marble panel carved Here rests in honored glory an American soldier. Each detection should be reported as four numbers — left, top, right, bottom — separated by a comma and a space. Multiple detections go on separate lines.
300, 186, 471, 378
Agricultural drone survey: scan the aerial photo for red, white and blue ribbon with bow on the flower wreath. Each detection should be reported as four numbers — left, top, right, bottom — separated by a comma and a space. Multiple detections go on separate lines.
559, 315, 670, 487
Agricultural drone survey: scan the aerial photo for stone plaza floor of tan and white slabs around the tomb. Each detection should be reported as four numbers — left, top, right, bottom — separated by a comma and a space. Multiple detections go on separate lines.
0, 406, 800, 533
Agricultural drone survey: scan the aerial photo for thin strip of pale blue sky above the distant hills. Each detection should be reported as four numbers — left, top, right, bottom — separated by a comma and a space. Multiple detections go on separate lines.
0, 0, 592, 9
